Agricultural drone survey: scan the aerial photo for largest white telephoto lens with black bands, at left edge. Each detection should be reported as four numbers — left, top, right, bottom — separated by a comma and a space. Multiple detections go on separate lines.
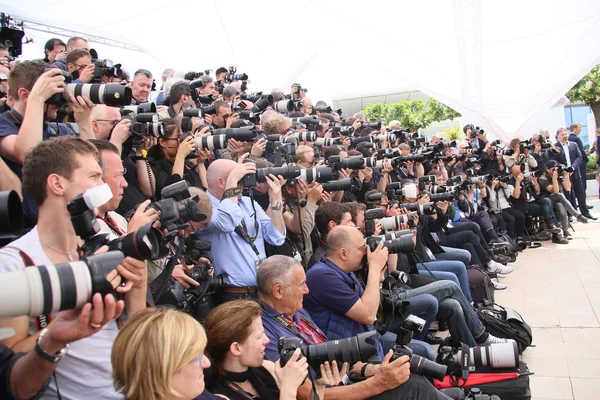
0, 251, 124, 319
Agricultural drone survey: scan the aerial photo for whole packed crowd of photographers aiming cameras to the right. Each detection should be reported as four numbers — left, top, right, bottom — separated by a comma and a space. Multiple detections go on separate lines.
0, 37, 596, 400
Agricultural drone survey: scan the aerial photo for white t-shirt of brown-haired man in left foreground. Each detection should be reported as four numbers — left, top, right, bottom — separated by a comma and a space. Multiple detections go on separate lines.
0, 227, 123, 400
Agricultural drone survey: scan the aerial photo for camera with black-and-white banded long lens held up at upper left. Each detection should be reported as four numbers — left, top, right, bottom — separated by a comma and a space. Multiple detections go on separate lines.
44, 68, 131, 107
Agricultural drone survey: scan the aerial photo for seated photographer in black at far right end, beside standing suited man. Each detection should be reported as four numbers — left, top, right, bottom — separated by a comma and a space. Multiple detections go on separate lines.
539, 160, 588, 244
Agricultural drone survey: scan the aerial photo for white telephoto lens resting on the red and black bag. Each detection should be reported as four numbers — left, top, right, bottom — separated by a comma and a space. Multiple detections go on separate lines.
456, 340, 519, 368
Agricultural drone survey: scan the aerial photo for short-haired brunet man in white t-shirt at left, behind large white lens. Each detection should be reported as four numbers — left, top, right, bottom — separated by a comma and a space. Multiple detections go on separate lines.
0, 137, 147, 400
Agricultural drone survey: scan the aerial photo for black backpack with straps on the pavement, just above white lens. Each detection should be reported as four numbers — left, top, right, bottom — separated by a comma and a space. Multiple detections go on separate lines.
476, 303, 533, 354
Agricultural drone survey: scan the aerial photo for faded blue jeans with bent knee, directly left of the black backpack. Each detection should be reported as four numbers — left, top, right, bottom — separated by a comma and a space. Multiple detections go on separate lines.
394, 281, 485, 347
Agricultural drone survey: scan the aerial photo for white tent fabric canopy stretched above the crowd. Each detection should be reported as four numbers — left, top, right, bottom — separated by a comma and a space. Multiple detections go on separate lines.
0, 0, 600, 139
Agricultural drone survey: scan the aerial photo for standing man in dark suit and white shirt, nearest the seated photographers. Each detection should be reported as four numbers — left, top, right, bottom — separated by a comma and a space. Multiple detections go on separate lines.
553, 128, 598, 220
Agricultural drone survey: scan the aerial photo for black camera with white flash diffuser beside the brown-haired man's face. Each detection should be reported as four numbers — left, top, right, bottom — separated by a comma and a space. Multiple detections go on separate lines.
67, 184, 166, 260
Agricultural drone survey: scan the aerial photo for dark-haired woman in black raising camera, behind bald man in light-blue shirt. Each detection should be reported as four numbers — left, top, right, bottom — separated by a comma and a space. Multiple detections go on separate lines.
144, 118, 209, 198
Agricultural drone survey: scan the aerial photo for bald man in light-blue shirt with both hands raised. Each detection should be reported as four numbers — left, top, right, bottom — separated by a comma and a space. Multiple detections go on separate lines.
198, 154, 286, 301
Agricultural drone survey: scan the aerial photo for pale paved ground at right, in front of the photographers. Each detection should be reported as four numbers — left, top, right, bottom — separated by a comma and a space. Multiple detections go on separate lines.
496, 198, 600, 400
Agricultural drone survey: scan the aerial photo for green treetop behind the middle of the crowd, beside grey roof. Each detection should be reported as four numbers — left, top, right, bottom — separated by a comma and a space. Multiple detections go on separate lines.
363, 98, 460, 131
